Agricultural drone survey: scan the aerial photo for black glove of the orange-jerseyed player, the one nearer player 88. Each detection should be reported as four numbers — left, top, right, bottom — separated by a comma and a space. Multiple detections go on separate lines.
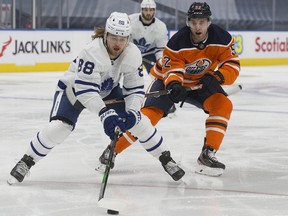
166, 81, 187, 103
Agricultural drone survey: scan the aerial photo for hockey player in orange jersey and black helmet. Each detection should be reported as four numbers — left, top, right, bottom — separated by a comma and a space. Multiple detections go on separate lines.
99, 2, 240, 176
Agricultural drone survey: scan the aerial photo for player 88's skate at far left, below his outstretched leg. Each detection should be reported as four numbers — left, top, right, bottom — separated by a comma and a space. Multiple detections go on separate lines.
7, 154, 35, 185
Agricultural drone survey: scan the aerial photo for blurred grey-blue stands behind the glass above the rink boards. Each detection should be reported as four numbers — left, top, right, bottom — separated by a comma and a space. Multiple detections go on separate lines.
0, 0, 288, 31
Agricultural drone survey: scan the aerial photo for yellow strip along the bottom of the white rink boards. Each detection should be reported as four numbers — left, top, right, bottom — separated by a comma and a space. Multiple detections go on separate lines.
0, 58, 288, 73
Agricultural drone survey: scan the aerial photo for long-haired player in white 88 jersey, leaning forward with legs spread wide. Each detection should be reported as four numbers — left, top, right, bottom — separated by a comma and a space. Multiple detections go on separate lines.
7, 12, 185, 184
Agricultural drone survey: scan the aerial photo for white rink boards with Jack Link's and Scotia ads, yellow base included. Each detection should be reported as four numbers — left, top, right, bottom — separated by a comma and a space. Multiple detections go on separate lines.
0, 30, 288, 72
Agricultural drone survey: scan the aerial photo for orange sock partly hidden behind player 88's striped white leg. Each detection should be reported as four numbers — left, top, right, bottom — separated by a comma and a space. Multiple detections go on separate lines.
115, 107, 164, 154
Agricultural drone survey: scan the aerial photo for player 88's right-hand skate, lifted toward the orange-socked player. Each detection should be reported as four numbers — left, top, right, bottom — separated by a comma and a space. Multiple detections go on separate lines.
159, 151, 185, 181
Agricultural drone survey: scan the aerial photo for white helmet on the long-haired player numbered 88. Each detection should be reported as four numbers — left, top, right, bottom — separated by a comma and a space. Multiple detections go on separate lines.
105, 12, 131, 36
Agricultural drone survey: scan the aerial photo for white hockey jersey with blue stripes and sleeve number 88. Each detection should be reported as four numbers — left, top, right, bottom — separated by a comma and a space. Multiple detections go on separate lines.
58, 38, 144, 114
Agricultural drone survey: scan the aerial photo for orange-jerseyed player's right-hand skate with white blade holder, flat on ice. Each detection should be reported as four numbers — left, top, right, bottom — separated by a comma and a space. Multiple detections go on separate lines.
195, 146, 225, 176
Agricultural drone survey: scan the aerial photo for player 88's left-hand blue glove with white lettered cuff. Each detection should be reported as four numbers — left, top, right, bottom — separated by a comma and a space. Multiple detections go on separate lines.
99, 108, 126, 140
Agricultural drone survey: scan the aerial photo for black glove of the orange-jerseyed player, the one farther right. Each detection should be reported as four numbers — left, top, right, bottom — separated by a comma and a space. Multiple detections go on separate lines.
197, 72, 227, 101
